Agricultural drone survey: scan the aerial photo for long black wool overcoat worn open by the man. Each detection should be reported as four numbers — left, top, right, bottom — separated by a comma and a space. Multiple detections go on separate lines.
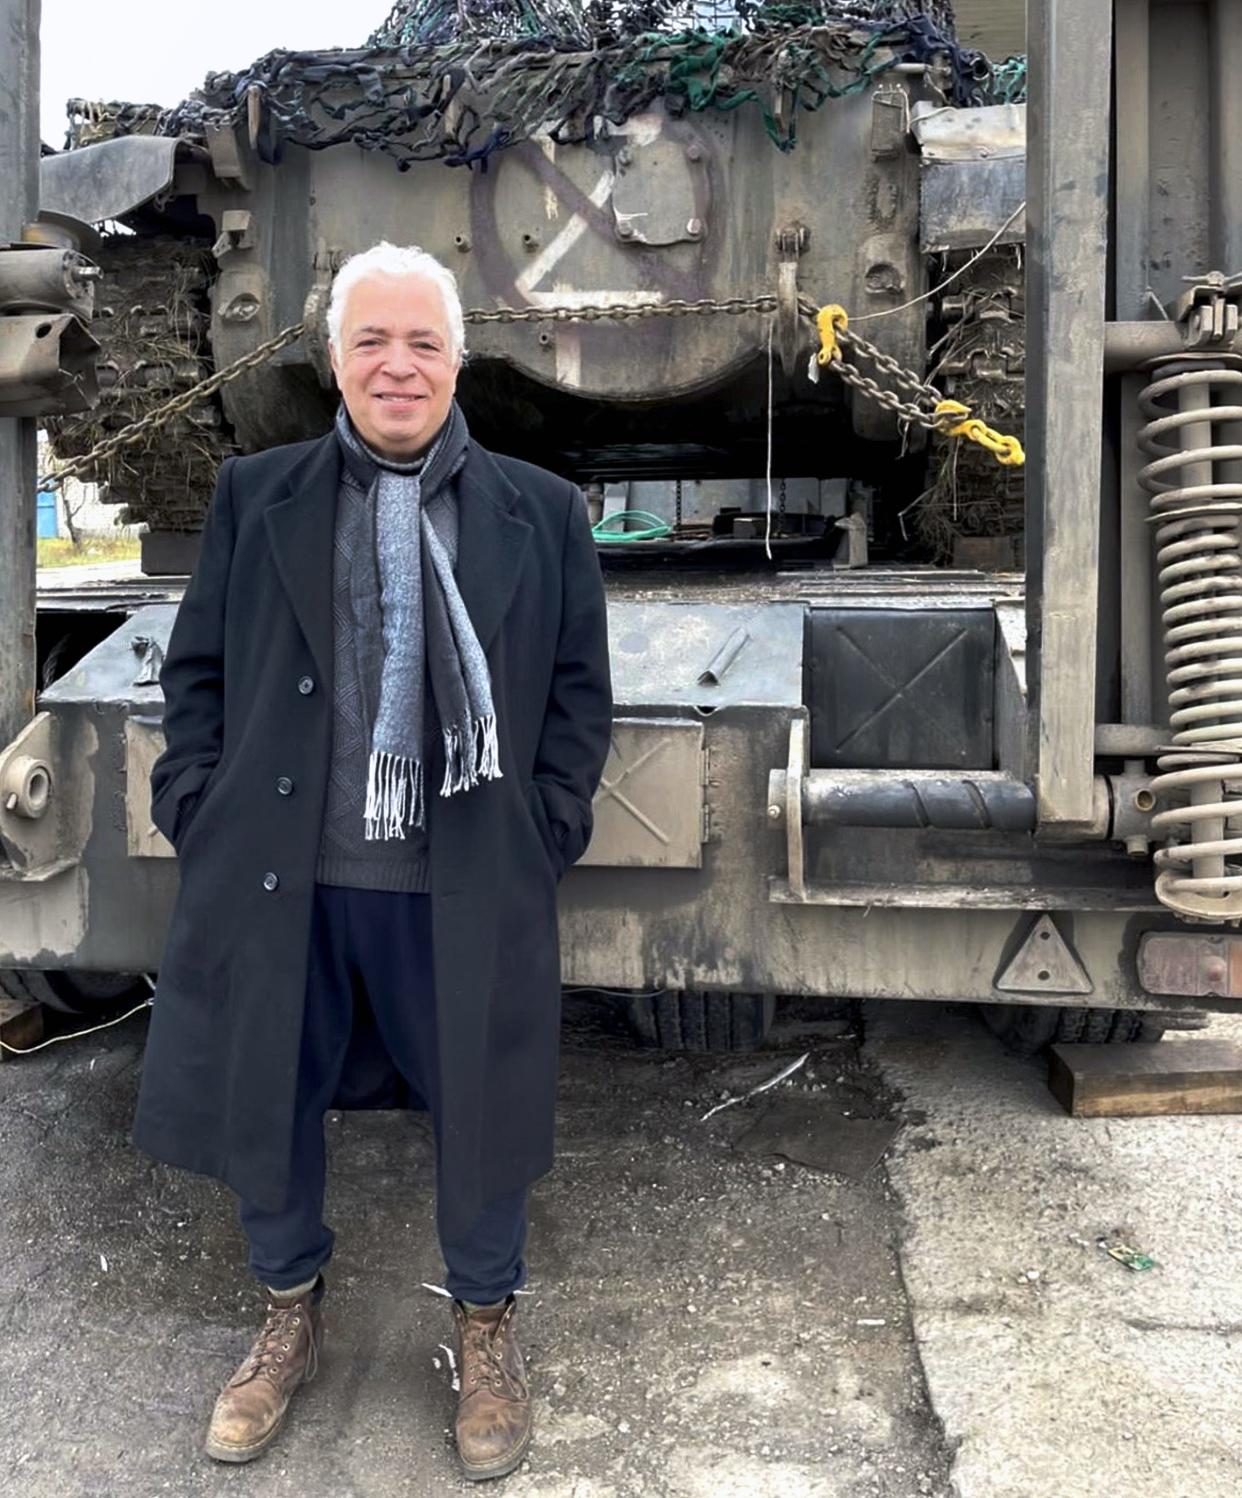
135, 434, 611, 1221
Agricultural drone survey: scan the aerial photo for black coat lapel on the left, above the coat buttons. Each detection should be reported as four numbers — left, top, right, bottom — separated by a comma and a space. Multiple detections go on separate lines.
264, 433, 340, 685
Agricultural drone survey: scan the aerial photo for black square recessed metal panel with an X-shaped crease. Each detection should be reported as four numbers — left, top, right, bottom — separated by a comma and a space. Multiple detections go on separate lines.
808, 608, 996, 770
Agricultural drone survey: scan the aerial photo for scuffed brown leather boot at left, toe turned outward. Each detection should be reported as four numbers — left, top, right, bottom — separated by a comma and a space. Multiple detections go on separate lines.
207, 1279, 324, 1462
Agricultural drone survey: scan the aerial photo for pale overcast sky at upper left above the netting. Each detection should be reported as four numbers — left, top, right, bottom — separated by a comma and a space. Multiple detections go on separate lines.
40, 0, 393, 148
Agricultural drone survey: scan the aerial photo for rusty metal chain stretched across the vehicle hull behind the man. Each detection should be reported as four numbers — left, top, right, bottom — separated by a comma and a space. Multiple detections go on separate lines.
39, 295, 942, 488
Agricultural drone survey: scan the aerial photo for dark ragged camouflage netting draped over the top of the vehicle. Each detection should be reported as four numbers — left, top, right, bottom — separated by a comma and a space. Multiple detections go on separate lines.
69, 0, 1016, 169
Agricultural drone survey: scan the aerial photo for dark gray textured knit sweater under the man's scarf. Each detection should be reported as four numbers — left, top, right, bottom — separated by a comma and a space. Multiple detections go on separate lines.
315, 466, 457, 894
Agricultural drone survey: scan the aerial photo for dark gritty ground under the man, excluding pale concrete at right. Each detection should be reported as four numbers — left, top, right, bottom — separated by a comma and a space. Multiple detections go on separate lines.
0, 998, 950, 1498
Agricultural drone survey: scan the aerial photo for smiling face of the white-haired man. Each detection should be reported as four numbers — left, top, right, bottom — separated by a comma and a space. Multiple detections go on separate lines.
328, 274, 461, 463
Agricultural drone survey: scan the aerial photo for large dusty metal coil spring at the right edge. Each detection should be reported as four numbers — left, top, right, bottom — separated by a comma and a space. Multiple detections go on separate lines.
1139, 360, 1242, 920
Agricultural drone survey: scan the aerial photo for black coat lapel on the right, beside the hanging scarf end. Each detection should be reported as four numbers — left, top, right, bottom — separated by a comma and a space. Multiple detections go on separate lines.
457, 442, 532, 650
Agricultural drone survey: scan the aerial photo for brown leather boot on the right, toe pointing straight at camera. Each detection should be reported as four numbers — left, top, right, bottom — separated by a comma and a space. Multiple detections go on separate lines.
452, 1296, 530, 1482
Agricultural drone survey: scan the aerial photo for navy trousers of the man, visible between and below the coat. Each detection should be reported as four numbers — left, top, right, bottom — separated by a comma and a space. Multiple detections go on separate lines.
241, 884, 526, 1305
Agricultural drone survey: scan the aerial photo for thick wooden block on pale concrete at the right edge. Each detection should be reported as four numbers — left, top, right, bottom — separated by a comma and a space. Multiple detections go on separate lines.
1047, 1040, 1242, 1119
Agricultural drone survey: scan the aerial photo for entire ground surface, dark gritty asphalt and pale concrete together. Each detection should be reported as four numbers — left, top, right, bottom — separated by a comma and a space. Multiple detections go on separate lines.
0, 996, 1242, 1498
